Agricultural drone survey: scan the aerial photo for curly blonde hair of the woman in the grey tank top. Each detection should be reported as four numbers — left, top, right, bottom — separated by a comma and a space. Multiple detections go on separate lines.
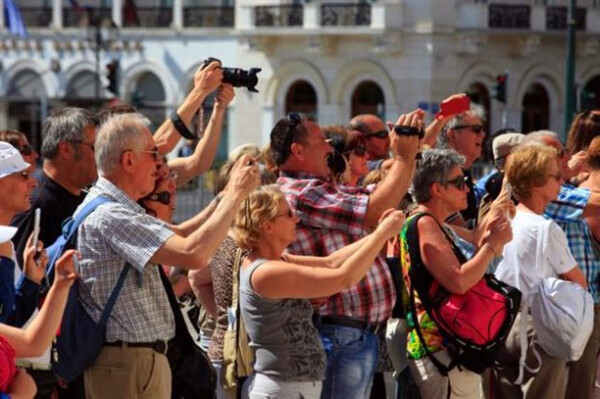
233, 184, 285, 250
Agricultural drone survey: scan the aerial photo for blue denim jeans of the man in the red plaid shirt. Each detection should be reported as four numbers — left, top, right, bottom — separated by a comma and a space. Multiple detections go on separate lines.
317, 324, 379, 399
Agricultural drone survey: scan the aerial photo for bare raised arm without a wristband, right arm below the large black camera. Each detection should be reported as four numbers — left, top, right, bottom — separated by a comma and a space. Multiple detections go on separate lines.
168, 84, 235, 187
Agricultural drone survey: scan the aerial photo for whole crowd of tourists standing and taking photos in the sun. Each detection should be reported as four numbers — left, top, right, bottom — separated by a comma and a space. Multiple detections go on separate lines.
0, 62, 600, 399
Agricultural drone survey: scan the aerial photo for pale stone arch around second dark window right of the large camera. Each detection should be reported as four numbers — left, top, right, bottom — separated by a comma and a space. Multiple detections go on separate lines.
331, 60, 399, 120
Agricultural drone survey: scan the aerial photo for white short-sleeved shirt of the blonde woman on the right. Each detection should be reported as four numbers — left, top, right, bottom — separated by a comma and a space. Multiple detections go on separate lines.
495, 210, 577, 297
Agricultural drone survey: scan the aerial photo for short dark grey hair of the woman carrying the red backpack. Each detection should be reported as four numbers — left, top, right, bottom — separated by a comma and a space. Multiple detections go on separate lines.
410, 148, 465, 204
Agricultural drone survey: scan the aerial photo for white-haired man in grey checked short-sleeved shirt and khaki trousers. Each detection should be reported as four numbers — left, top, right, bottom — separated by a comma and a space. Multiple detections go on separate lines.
75, 114, 259, 398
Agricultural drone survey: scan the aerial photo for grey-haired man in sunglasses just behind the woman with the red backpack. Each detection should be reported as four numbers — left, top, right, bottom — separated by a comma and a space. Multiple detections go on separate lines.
438, 105, 486, 229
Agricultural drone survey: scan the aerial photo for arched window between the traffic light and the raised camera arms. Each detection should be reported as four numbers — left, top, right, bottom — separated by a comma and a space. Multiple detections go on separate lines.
129, 72, 166, 128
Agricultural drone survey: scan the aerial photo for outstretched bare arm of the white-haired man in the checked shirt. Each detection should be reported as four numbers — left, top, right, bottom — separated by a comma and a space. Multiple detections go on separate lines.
151, 155, 260, 269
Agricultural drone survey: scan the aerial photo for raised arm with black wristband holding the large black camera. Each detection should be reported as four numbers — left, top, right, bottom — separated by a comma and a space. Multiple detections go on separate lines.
153, 61, 223, 154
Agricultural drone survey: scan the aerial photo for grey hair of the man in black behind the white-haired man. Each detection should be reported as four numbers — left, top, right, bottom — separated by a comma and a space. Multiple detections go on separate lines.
42, 107, 99, 159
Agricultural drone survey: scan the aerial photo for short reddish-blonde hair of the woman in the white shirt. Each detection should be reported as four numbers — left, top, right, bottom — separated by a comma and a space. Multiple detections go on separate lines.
505, 144, 557, 201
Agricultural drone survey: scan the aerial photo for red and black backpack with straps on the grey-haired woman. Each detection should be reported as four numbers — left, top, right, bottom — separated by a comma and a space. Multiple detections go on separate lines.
400, 213, 521, 375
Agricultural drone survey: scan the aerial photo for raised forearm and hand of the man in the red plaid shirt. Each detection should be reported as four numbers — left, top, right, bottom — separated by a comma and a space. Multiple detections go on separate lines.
365, 109, 423, 228
